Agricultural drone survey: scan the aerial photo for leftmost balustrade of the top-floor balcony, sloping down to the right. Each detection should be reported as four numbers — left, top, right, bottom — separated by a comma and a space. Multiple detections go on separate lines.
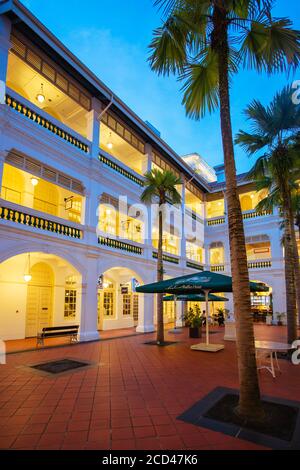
5, 92, 90, 154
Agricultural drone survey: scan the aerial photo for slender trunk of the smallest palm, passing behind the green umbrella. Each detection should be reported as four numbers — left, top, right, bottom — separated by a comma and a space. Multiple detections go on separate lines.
156, 204, 164, 344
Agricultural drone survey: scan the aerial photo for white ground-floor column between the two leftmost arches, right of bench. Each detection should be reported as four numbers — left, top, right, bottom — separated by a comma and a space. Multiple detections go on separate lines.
79, 254, 99, 341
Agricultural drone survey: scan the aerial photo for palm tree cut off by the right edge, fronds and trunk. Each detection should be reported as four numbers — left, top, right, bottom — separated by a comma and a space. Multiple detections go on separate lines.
236, 94, 300, 343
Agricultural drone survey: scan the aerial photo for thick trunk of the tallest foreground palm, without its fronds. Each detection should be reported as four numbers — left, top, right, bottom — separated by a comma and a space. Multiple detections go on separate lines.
216, 12, 263, 419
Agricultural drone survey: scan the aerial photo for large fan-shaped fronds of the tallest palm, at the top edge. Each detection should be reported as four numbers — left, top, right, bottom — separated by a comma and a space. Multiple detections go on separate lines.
149, 0, 300, 119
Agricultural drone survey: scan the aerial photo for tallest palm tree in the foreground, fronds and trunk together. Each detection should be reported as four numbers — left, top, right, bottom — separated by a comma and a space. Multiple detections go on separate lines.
149, 0, 300, 419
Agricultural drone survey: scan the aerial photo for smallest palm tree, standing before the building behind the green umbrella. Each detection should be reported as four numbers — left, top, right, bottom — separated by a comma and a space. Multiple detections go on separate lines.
141, 169, 182, 345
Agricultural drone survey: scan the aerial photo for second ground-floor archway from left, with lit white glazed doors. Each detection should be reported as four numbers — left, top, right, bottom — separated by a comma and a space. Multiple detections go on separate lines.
97, 267, 144, 330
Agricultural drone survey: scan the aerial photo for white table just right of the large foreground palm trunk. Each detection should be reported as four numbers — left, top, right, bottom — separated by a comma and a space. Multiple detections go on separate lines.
255, 341, 293, 379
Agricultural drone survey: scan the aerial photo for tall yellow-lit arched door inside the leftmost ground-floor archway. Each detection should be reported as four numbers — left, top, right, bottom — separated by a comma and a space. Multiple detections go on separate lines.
25, 262, 54, 338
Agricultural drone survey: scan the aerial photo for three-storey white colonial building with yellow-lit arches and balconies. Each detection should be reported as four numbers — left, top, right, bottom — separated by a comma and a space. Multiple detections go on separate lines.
0, 0, 292, 340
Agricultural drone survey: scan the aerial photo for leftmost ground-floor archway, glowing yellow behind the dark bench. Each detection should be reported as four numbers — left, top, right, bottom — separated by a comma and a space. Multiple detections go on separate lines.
0, 252, 82, 340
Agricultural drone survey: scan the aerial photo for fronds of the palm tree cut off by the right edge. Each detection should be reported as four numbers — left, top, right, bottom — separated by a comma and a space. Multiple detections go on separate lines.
235, 86, 300, 214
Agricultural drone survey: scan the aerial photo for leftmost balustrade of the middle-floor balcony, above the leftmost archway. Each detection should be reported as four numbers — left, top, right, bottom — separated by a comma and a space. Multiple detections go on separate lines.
0, 203, 82, 238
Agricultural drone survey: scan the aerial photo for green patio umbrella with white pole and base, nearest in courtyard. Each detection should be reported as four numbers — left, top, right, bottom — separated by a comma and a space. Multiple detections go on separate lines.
136, 271, 268, 352
